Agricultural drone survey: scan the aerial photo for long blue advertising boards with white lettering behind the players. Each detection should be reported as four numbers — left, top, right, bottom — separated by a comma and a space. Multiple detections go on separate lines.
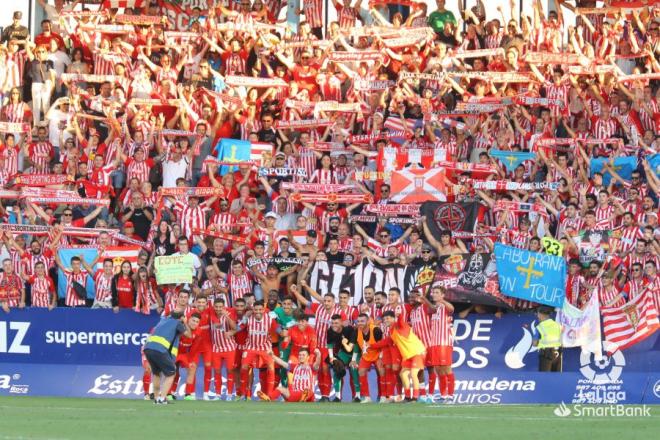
0, 308, 660, 404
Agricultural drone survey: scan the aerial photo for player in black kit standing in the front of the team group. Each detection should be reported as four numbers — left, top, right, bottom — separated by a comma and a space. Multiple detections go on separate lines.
327, 315, 360, 402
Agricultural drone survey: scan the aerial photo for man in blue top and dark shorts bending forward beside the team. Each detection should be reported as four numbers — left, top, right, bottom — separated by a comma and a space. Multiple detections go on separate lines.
144, 311, 201, 405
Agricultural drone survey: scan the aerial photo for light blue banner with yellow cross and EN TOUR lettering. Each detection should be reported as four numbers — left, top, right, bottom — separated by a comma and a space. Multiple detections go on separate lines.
495, 243, 566, 307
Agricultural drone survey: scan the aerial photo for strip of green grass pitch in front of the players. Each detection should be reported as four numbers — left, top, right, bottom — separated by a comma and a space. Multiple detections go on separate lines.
0, 397, 660, 440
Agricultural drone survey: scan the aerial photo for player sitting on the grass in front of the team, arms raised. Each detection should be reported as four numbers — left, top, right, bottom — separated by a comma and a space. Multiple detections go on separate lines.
257, 348, 321, 402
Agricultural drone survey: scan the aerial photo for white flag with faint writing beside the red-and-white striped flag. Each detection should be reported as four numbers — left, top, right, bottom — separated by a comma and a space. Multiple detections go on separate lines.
557, 295, 603, 360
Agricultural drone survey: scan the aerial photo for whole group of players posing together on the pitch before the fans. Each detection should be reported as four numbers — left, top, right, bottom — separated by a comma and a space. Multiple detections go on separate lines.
142, 281, 454, 403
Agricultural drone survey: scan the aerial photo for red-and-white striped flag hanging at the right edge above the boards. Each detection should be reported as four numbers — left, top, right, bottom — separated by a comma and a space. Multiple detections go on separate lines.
601, 288, 660, 350
